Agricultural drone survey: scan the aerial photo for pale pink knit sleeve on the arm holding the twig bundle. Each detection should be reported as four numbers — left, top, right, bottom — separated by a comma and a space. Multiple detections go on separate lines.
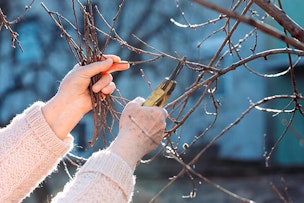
0, 102, 72, 202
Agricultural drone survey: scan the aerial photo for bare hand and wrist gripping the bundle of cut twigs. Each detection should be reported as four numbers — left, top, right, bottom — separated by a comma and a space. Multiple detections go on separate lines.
42, 55, 129, 140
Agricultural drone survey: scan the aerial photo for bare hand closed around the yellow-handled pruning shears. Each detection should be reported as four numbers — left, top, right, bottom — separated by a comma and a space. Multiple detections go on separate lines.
108, 97, 168, 169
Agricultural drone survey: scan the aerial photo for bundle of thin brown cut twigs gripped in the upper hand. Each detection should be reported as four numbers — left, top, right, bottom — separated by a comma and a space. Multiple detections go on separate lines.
41, 0, 131, 148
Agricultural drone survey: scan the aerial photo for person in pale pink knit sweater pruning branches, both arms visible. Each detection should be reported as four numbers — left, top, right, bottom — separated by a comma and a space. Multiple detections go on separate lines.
0, 55, 167, 203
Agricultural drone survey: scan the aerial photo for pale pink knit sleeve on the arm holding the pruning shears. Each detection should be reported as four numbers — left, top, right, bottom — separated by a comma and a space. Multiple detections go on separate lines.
52, 150, 135, 203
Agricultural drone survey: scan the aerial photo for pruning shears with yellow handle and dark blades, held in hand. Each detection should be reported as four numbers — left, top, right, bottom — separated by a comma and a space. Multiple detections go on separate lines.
143, 57, 186, 107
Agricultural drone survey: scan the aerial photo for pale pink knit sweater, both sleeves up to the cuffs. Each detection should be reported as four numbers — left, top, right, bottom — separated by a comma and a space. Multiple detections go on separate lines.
0, 102, 135, 203
